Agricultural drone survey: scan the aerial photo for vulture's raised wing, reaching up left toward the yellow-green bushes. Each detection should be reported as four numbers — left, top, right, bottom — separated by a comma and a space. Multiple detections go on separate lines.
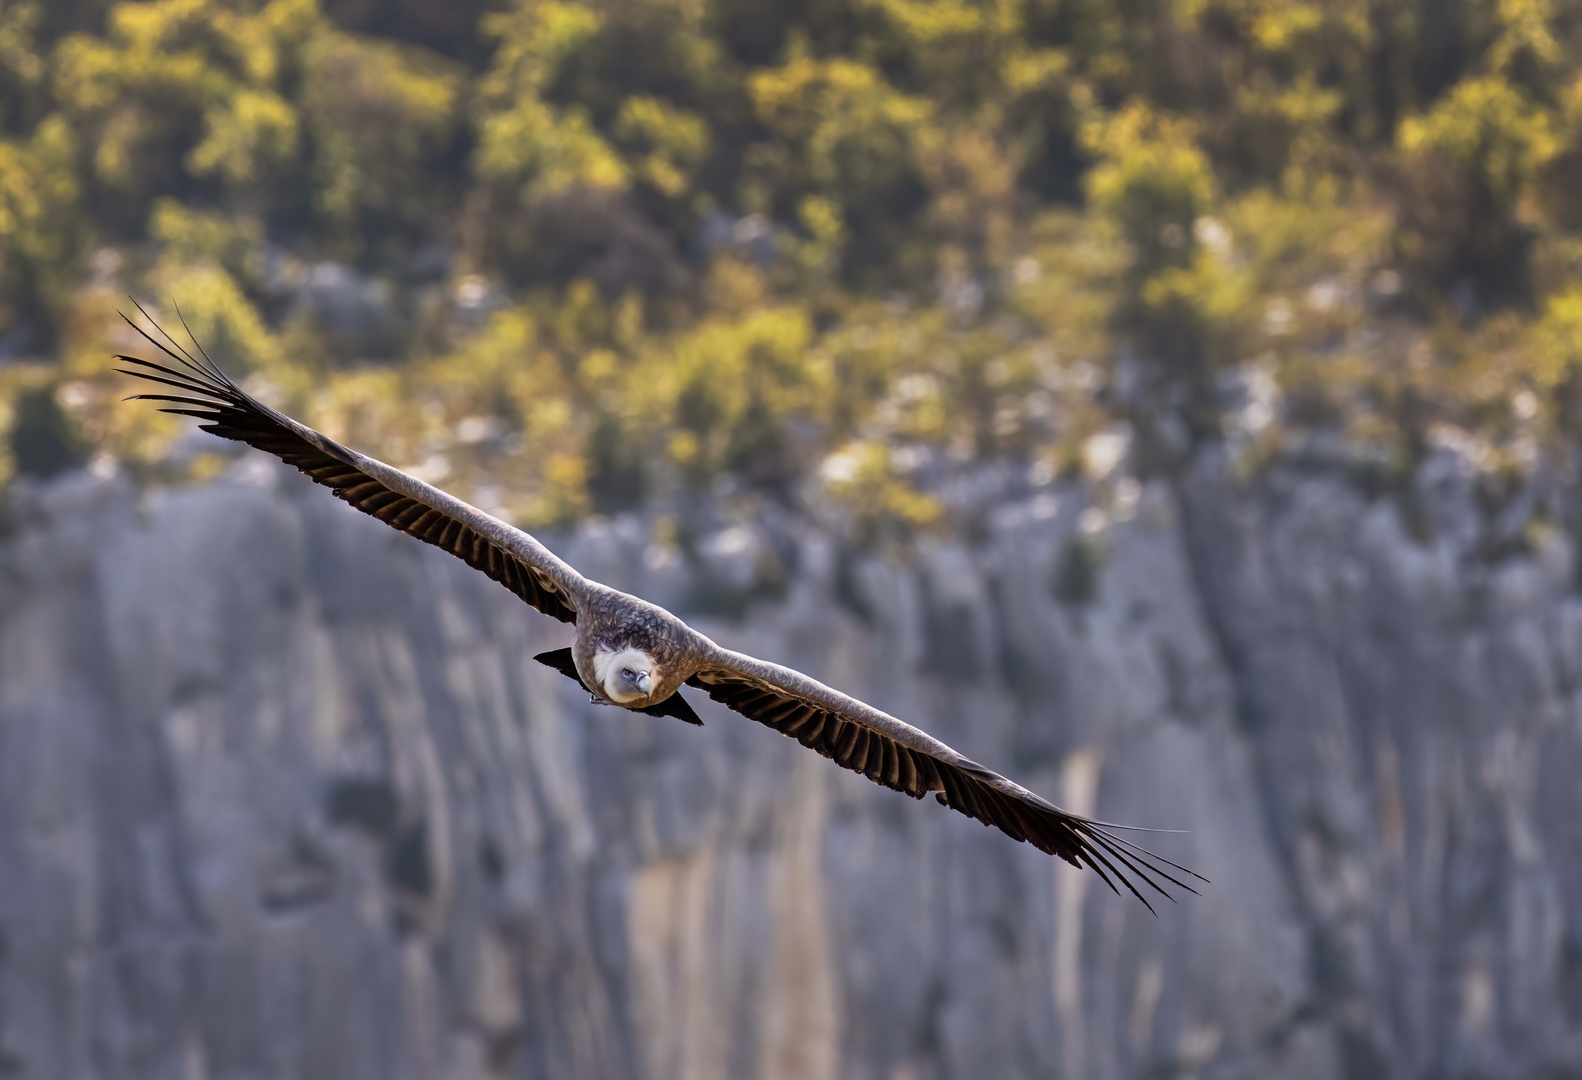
115, 305, 585, 623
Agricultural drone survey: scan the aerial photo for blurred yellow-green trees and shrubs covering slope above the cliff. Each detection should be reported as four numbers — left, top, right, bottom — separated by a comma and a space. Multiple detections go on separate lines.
0, 0, 1582, 530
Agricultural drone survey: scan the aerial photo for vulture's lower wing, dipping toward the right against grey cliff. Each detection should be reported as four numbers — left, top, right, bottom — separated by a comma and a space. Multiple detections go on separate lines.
687, 648, 1205, 911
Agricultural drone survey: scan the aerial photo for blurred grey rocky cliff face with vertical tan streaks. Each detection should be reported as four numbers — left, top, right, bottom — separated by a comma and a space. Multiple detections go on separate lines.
0, 459, 1582, 1080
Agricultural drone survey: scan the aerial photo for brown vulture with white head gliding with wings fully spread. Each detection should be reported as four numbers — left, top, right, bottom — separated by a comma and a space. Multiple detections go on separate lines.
115, 300, 1205, 911
